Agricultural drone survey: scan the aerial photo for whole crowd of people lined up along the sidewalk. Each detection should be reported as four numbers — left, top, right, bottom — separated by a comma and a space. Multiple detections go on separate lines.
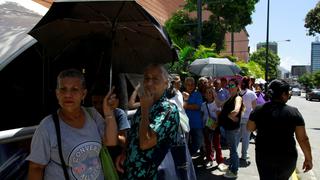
27, 64, 313, 180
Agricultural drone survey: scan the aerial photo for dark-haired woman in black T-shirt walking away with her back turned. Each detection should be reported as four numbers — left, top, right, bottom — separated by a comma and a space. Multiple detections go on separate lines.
247, 79, 313, 180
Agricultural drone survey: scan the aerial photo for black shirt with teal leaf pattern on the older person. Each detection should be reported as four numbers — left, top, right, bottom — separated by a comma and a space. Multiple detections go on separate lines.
124, 95, 179, 179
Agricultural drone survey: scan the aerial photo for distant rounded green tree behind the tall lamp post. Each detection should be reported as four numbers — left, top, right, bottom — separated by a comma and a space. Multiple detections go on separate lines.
250, 48, 280, 79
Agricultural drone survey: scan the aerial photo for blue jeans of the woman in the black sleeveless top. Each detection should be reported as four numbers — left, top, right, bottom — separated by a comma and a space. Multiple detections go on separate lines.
225, 128, 240, 174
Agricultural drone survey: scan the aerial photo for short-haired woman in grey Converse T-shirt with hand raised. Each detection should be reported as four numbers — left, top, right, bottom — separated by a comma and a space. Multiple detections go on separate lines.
27, 69, 117, 180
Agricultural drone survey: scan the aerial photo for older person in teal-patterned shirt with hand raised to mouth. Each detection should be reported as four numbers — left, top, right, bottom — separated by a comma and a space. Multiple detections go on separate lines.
117, 64, 179, 179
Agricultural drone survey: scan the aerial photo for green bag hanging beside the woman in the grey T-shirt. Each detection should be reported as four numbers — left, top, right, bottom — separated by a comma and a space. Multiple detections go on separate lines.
99, 145, 119, 180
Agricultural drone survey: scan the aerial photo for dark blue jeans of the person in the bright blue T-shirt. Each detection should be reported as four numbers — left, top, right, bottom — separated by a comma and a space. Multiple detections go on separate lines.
188, 128, 203, 156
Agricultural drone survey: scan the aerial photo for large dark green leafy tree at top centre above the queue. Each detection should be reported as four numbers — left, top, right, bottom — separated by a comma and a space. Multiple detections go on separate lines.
165, 0, 258, 53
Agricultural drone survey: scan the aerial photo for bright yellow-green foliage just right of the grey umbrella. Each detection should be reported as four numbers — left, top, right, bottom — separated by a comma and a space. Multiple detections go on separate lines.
236, 61, 264, 78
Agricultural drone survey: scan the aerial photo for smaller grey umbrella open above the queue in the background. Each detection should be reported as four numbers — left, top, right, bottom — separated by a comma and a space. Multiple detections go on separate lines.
189, 57, 240, 77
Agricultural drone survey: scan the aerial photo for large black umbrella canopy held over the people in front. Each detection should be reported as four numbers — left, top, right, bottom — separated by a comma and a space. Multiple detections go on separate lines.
29, 0, 177, 73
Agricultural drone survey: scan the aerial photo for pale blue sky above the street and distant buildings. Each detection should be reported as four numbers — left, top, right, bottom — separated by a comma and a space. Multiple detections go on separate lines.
246, 0, 319, 71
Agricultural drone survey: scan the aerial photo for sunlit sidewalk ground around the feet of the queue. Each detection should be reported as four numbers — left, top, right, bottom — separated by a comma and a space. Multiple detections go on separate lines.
193, 143, 300, 180
